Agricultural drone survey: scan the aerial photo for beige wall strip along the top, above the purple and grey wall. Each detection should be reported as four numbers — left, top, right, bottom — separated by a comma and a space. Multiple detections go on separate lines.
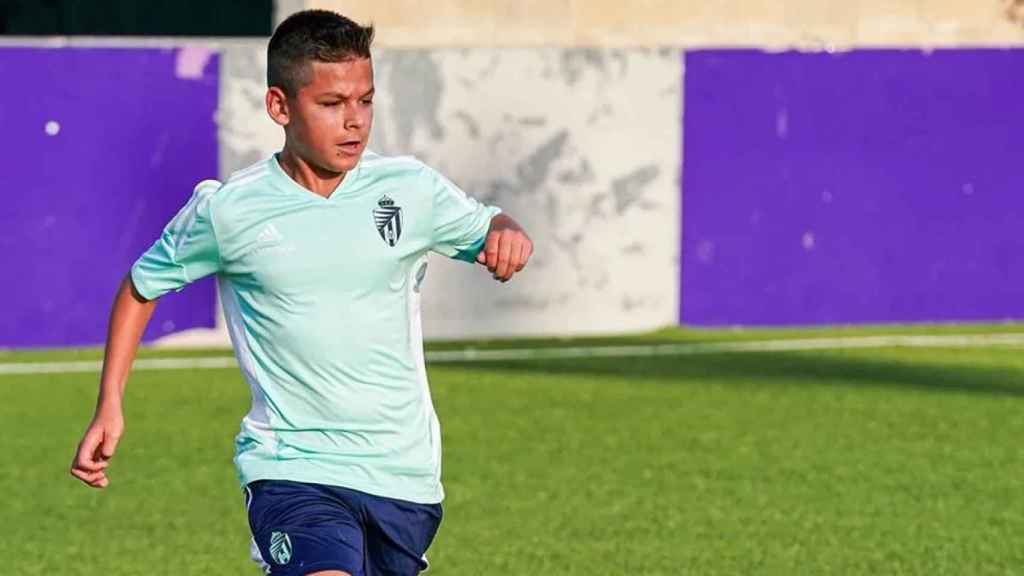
290, 0, 1024, 49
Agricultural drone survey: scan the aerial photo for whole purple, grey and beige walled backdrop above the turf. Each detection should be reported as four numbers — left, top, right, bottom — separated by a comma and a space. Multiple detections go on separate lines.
0, 0, 1024, 347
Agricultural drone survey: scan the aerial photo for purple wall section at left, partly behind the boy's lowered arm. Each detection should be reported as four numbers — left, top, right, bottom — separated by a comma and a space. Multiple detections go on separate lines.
0, 48, 218, 347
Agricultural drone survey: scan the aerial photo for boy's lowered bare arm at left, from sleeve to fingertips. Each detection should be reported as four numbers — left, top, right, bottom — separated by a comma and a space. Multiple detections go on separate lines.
71, 275, 157, 488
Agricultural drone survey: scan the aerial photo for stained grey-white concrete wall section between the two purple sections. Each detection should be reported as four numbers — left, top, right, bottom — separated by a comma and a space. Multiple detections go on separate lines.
218, 43, 682, 337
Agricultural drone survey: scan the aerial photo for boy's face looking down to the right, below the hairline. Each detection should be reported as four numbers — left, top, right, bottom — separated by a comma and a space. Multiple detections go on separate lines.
268, 58, 374, 173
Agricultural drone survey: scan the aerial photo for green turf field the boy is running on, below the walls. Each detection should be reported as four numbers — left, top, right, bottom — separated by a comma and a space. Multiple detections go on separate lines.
6, 326, 1024, 576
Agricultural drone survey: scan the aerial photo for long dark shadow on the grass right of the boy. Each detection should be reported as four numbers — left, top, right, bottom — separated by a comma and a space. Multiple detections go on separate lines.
435, 352, 1024, 397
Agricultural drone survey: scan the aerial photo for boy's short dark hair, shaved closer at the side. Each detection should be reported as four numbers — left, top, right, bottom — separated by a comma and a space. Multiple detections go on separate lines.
266, 10, 374, 95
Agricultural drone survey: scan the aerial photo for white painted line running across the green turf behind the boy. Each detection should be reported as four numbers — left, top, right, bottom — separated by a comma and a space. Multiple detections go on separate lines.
6, 333, 1024, 375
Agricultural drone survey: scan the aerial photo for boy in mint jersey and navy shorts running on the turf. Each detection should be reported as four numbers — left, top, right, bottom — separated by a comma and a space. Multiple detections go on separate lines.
71, 10, 532, 576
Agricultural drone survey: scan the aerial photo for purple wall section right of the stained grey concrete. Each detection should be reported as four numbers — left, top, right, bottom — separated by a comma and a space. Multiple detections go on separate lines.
680, 50, 1024, 325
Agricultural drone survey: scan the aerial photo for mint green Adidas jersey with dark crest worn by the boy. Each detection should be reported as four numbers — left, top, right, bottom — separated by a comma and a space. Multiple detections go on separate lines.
131, 152, 499, 503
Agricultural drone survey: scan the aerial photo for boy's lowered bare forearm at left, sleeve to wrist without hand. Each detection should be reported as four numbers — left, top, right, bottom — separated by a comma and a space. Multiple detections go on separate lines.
96, 275, 157, 412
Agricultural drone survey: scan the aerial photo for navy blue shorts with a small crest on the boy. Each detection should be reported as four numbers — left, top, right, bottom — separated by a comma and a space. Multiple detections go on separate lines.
246, 480, 441, 576
